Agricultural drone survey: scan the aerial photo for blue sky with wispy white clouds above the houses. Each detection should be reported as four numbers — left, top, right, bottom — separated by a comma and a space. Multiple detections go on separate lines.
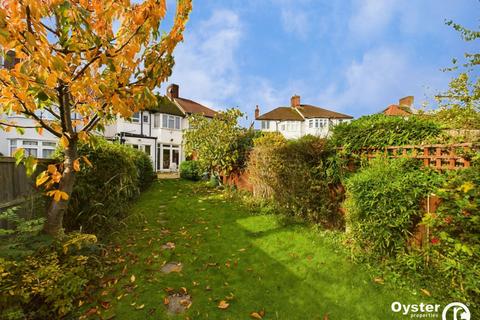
162, 0, 480, 123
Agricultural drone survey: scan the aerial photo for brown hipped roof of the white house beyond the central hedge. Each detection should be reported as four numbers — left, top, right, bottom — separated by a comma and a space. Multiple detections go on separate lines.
257, 104, 353, 121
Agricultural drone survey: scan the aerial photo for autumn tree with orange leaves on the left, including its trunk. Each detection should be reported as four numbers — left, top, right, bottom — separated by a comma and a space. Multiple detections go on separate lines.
0, 0, 191, 235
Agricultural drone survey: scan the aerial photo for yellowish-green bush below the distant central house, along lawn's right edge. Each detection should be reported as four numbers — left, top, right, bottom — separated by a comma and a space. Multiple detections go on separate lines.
248, 134, 343, 227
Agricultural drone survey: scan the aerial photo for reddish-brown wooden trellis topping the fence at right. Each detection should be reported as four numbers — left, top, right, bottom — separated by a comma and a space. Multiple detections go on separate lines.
350, 143, 480, 170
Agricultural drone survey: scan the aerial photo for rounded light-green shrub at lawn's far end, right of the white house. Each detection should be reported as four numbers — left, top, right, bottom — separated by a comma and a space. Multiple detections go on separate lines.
184, 109, 255, 175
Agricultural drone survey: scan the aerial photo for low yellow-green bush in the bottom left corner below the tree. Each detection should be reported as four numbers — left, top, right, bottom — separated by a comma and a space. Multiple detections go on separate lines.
0, 210, 99, 319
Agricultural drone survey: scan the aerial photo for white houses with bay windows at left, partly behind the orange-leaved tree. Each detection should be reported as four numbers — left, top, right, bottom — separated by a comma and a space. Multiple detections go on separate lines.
0, 84, 216, 171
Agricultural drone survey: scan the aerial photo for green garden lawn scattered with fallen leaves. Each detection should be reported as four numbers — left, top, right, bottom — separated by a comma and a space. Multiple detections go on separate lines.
85, 180, 432, 319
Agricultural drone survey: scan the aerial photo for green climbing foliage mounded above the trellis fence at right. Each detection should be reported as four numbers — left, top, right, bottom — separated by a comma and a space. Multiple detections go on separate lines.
331, 114, 441, 152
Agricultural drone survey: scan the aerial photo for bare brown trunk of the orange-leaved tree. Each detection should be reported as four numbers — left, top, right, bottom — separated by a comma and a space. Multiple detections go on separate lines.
43, 141, 77, 236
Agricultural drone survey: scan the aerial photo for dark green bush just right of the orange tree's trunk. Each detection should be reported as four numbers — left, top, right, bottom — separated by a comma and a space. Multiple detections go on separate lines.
57, 139, 154, 233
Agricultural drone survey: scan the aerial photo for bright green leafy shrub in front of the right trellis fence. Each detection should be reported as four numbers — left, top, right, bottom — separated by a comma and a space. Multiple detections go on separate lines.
345, 158, 436, 259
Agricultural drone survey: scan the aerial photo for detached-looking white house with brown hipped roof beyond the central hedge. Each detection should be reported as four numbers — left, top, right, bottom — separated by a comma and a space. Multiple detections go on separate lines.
255, 95, 353, 139
